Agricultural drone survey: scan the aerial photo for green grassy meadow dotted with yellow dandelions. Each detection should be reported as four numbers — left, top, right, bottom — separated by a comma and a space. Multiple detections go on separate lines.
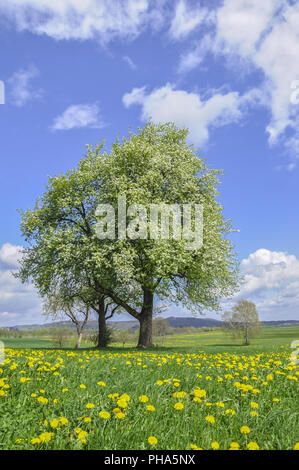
0, 327, 299, 450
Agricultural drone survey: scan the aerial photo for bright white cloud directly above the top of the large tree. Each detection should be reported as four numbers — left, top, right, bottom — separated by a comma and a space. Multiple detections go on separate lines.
123, 84, 259, 145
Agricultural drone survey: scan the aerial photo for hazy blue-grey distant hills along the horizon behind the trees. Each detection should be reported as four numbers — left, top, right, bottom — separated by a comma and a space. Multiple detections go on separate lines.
4, 317, 299, 331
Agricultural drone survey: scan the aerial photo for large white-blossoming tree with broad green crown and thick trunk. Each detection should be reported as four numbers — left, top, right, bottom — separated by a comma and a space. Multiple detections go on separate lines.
18, 122, 238, 347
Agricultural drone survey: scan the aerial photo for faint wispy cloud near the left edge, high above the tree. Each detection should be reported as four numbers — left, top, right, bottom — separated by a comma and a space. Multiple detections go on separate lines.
8, 65, 43, 107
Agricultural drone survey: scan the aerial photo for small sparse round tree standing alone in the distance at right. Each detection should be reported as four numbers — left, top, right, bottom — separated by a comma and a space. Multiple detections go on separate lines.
222, 299, 261, 346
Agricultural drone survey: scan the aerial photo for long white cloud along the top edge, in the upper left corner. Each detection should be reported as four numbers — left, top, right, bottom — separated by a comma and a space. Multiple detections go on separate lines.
0, 0, 157, 42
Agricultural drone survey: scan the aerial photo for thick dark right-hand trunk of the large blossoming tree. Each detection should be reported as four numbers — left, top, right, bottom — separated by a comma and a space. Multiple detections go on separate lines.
137, 289, 154, 349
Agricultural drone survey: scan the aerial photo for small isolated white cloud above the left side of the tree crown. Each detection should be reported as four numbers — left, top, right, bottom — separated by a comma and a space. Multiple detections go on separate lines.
52, 103, 105, 130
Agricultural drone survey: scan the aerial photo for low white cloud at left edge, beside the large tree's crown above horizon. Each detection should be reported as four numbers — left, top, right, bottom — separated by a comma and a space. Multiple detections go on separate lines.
0, 243, 41, 327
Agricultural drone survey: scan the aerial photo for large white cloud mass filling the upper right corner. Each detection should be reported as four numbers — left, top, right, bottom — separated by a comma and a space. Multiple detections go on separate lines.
179, 0, 299, 165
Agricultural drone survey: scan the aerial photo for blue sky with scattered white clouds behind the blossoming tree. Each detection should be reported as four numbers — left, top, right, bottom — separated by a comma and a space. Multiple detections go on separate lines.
0, 0, 299, 326
